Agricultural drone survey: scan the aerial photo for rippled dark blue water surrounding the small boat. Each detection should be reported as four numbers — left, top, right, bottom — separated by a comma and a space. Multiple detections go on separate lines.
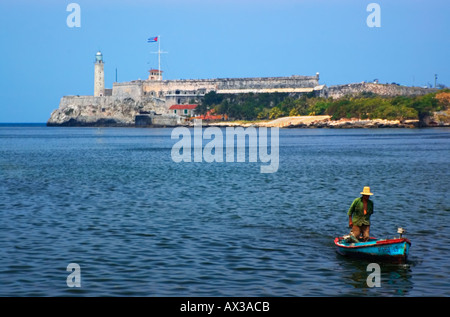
0, 126, 450, 296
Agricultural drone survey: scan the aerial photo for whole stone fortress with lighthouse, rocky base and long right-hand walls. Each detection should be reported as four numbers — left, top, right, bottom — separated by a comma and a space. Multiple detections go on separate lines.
47, 52, 438, 126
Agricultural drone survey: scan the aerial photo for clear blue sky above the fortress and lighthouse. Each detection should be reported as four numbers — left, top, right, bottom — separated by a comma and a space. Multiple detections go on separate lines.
0, 0, 450, 122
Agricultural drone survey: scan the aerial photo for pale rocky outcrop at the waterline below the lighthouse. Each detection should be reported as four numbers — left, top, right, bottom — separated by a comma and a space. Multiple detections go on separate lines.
47, 96, 166, 127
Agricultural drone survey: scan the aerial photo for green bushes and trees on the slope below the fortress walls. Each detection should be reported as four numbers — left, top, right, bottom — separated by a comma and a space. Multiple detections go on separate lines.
197, 89, 450, 120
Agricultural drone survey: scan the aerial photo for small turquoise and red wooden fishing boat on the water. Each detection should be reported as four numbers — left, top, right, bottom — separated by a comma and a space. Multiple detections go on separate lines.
334, 228, 411, 263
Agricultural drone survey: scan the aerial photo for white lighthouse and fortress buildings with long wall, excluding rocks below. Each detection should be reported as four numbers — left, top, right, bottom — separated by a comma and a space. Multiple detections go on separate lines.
94, 52, 324, 109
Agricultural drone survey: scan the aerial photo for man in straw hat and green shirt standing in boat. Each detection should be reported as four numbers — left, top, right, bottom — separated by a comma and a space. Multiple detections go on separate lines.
347, 186, 373, 241
